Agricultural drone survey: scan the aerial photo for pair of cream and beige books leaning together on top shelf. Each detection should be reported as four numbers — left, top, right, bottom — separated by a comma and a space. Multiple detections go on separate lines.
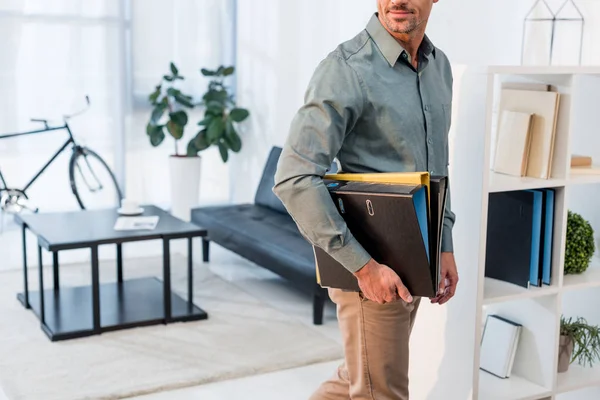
492, 88, 560, 179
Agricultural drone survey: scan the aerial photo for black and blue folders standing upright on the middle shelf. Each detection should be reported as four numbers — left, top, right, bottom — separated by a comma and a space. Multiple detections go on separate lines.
485, 189, 555, 288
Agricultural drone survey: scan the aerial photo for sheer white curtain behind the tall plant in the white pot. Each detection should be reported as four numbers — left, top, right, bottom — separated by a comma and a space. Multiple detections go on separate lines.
127, 0, 235, 207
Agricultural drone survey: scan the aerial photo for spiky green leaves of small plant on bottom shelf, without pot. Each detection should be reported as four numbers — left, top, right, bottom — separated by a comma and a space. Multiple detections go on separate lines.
560, 316, 600, 367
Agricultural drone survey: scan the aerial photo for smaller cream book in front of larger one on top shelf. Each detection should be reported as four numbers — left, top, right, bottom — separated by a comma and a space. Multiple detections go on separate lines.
493, 110, 533, 177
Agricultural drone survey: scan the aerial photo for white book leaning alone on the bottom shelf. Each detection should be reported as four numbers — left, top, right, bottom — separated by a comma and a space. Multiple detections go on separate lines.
480, 315, 522, 378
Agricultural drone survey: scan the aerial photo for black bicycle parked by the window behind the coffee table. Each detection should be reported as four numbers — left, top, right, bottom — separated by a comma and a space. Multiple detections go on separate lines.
0, 96, 123, 214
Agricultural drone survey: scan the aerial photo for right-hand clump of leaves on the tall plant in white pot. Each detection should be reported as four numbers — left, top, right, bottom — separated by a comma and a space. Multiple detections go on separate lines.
187, 66, 250, 162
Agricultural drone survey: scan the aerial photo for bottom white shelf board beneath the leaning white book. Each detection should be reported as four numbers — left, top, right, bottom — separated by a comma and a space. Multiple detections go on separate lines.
479, 371, 552, 400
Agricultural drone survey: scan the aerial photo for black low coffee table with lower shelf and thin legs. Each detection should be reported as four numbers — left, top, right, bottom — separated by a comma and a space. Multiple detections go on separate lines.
15, 206, 208, 341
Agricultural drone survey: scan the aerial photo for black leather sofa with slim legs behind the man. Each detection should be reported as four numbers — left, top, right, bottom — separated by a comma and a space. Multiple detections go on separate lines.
191, 147, 335, 325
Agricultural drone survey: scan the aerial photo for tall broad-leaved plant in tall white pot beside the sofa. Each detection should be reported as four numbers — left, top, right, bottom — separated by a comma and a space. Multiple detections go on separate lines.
146, 63, 250, 221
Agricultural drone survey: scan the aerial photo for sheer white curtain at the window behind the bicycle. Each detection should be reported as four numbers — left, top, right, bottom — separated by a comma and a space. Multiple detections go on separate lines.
0, 0, 123, 211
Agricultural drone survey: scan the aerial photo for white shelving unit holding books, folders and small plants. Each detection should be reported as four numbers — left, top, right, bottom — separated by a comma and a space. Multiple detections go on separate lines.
447, 67, 600, 400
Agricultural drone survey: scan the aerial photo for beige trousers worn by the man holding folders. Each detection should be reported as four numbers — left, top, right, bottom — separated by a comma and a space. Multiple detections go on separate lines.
310, 289, 420, 400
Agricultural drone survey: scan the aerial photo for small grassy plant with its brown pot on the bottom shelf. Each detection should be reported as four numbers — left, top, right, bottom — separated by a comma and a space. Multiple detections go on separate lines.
558, 317, 600, 373
